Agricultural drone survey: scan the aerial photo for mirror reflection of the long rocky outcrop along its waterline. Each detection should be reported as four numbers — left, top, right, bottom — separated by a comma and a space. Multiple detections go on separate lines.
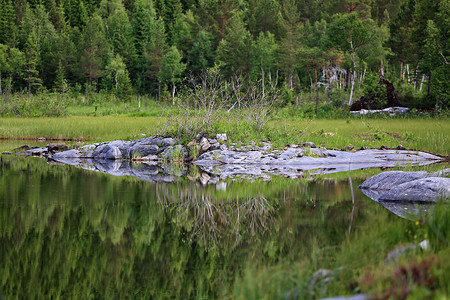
49, 157, 446, 184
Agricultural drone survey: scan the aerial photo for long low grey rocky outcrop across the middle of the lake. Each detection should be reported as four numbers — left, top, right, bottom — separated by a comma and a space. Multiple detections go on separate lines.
6, 134, 443, 184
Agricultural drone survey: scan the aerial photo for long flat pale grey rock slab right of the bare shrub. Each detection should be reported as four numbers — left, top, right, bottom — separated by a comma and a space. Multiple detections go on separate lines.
194, 147, 442, 178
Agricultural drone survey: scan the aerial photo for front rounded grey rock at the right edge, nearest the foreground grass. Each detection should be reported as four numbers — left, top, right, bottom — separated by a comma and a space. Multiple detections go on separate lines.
379, 177, 450, 203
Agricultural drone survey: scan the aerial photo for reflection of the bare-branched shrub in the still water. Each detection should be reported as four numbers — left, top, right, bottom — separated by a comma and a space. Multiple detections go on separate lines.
157, 186, 275, 247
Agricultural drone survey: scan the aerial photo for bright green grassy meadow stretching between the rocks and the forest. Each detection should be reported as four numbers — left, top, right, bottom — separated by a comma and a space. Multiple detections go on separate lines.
0, 97, 450, 156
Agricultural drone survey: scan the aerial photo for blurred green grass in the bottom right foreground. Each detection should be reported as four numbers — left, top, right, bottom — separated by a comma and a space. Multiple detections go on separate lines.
233, 204, 450, 299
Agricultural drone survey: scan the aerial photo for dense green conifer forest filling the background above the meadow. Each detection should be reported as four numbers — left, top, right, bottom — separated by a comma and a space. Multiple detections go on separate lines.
0, 0, 450, 108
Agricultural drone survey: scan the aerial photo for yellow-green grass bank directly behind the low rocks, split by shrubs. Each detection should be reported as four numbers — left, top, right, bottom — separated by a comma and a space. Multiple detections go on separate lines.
0, 114, 450, 156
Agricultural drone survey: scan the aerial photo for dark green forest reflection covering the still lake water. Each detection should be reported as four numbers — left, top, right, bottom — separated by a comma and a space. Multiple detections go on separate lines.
0, 157, 384, 299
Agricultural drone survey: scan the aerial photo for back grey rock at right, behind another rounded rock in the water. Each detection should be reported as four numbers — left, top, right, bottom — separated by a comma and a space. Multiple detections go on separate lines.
359, 171, 428, 191
